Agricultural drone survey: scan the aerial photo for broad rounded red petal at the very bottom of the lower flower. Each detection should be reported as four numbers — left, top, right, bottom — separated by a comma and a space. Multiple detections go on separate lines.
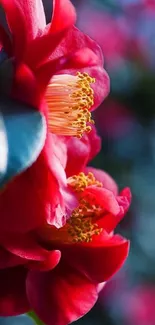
27, 265, 98, 325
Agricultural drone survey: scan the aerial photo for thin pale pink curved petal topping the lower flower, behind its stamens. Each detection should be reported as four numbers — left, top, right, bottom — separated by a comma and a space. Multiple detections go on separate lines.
86, 167, 118, 195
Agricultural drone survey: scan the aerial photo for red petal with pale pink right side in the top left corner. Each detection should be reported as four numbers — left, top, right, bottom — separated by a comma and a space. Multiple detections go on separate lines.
0, 0, 46, 61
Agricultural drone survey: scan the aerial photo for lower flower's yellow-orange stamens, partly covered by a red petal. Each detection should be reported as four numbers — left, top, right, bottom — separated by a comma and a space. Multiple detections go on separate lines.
67, 173, 102, 242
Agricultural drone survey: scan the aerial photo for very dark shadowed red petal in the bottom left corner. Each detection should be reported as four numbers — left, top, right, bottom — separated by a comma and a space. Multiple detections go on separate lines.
0, 267, 30, 316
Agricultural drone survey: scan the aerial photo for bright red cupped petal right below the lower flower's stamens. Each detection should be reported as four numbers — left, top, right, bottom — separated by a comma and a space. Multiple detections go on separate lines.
62, 236, 129, 283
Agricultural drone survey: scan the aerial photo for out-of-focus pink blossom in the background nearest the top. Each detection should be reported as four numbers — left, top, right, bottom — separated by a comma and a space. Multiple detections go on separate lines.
78, 2, 130, 64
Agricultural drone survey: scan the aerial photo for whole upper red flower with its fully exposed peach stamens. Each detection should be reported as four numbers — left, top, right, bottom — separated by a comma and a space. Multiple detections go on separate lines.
0, 0, 109, 232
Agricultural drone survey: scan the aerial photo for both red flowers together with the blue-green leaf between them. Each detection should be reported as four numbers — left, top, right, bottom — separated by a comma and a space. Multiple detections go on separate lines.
0, 0, 131, 325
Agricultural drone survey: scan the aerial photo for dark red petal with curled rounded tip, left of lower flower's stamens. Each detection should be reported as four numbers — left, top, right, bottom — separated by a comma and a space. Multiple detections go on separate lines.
0, 233, 61, 271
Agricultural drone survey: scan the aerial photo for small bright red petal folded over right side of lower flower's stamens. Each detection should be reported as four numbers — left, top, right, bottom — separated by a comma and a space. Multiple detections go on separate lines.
83, 186, 120, 215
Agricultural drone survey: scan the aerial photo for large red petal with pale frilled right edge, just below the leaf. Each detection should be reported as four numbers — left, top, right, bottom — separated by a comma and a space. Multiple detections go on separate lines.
0, 132, 77, 233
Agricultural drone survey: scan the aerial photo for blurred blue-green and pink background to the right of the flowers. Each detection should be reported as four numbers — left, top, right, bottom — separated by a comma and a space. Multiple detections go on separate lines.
0, 0, 155, 325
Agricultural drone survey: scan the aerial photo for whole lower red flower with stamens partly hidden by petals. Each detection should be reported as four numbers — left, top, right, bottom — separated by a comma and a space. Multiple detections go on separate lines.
0, 131, 131, 325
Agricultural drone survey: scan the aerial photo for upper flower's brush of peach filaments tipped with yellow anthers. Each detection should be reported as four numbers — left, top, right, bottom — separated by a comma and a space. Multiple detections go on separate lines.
45, 72, 95, 138
